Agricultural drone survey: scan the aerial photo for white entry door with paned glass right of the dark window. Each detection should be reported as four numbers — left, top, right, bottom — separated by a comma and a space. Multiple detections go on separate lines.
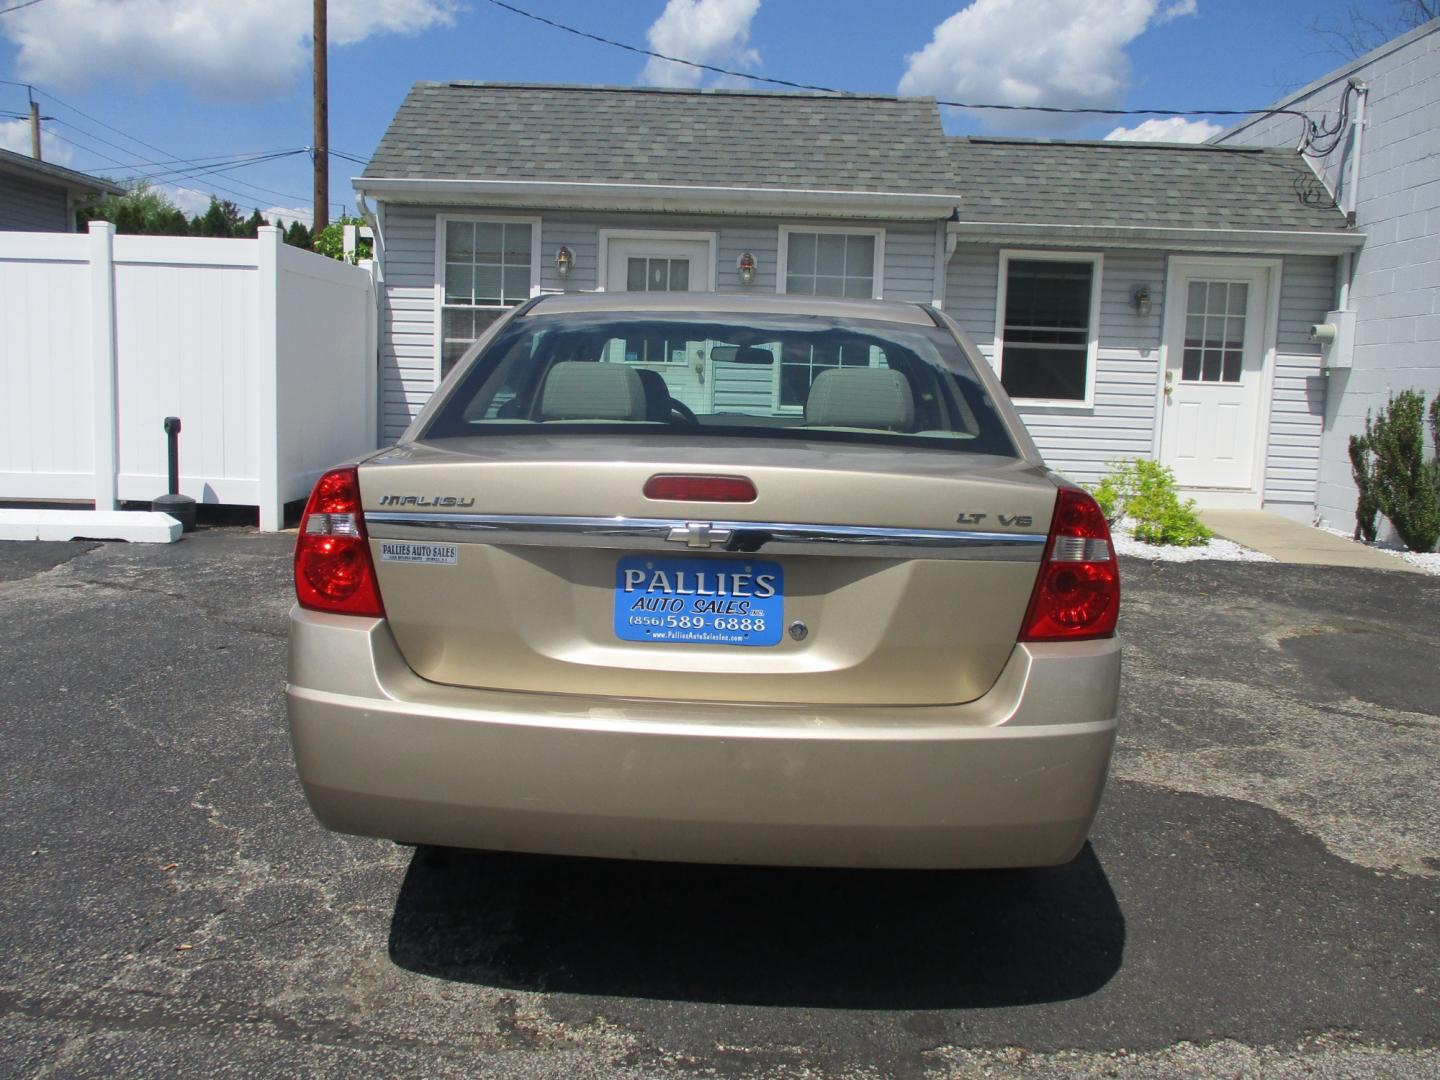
1159, 262, 1272, 501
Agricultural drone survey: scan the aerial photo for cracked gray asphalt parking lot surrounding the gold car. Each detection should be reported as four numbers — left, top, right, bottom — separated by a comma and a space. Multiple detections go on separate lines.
0, 528, 1440, 1079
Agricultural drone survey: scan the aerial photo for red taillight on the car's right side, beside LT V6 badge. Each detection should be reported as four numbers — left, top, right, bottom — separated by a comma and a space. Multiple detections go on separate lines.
1020, 488, 1120, 641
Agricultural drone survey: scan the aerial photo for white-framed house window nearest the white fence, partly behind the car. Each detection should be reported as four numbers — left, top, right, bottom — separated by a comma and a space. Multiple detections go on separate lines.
441, 220, 537, 379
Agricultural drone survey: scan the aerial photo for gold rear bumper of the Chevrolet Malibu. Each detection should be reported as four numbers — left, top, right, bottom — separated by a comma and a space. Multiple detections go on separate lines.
287, 608, 1120, 867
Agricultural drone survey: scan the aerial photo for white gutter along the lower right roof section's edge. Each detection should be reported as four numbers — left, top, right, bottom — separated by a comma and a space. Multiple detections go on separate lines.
946, 222, 1365, 255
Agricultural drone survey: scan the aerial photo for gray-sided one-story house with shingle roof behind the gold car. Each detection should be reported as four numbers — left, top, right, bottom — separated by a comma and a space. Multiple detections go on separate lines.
354, 84, 1364, 521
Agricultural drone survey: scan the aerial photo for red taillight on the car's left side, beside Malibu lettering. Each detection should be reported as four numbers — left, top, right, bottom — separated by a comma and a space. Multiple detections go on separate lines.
295, 467, 384, 618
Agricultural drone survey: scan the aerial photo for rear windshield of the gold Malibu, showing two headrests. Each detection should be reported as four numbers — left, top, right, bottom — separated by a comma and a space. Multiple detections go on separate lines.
420, 312, 1017, 456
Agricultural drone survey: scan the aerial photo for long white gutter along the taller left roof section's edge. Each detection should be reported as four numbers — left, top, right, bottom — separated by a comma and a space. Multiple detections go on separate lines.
351, 176, 960, 222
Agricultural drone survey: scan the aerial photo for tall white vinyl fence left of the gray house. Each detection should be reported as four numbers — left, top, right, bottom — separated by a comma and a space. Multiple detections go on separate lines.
0, 222, 377, 530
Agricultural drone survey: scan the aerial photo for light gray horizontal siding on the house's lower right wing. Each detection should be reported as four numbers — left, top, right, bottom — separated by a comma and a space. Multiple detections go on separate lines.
945, 245, 1335, 501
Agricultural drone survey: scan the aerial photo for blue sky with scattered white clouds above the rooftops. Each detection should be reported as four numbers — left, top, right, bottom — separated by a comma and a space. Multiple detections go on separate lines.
0, 0, 1394, 220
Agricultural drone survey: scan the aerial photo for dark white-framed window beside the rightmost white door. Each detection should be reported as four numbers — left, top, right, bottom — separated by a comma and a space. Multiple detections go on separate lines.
998, 256, 1100, 403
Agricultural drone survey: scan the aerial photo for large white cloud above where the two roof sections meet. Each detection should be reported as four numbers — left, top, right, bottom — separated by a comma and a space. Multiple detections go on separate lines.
900, 0, 1195, 128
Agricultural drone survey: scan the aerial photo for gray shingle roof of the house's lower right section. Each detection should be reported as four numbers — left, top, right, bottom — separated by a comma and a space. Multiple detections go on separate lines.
946, 137, 1345, 230
